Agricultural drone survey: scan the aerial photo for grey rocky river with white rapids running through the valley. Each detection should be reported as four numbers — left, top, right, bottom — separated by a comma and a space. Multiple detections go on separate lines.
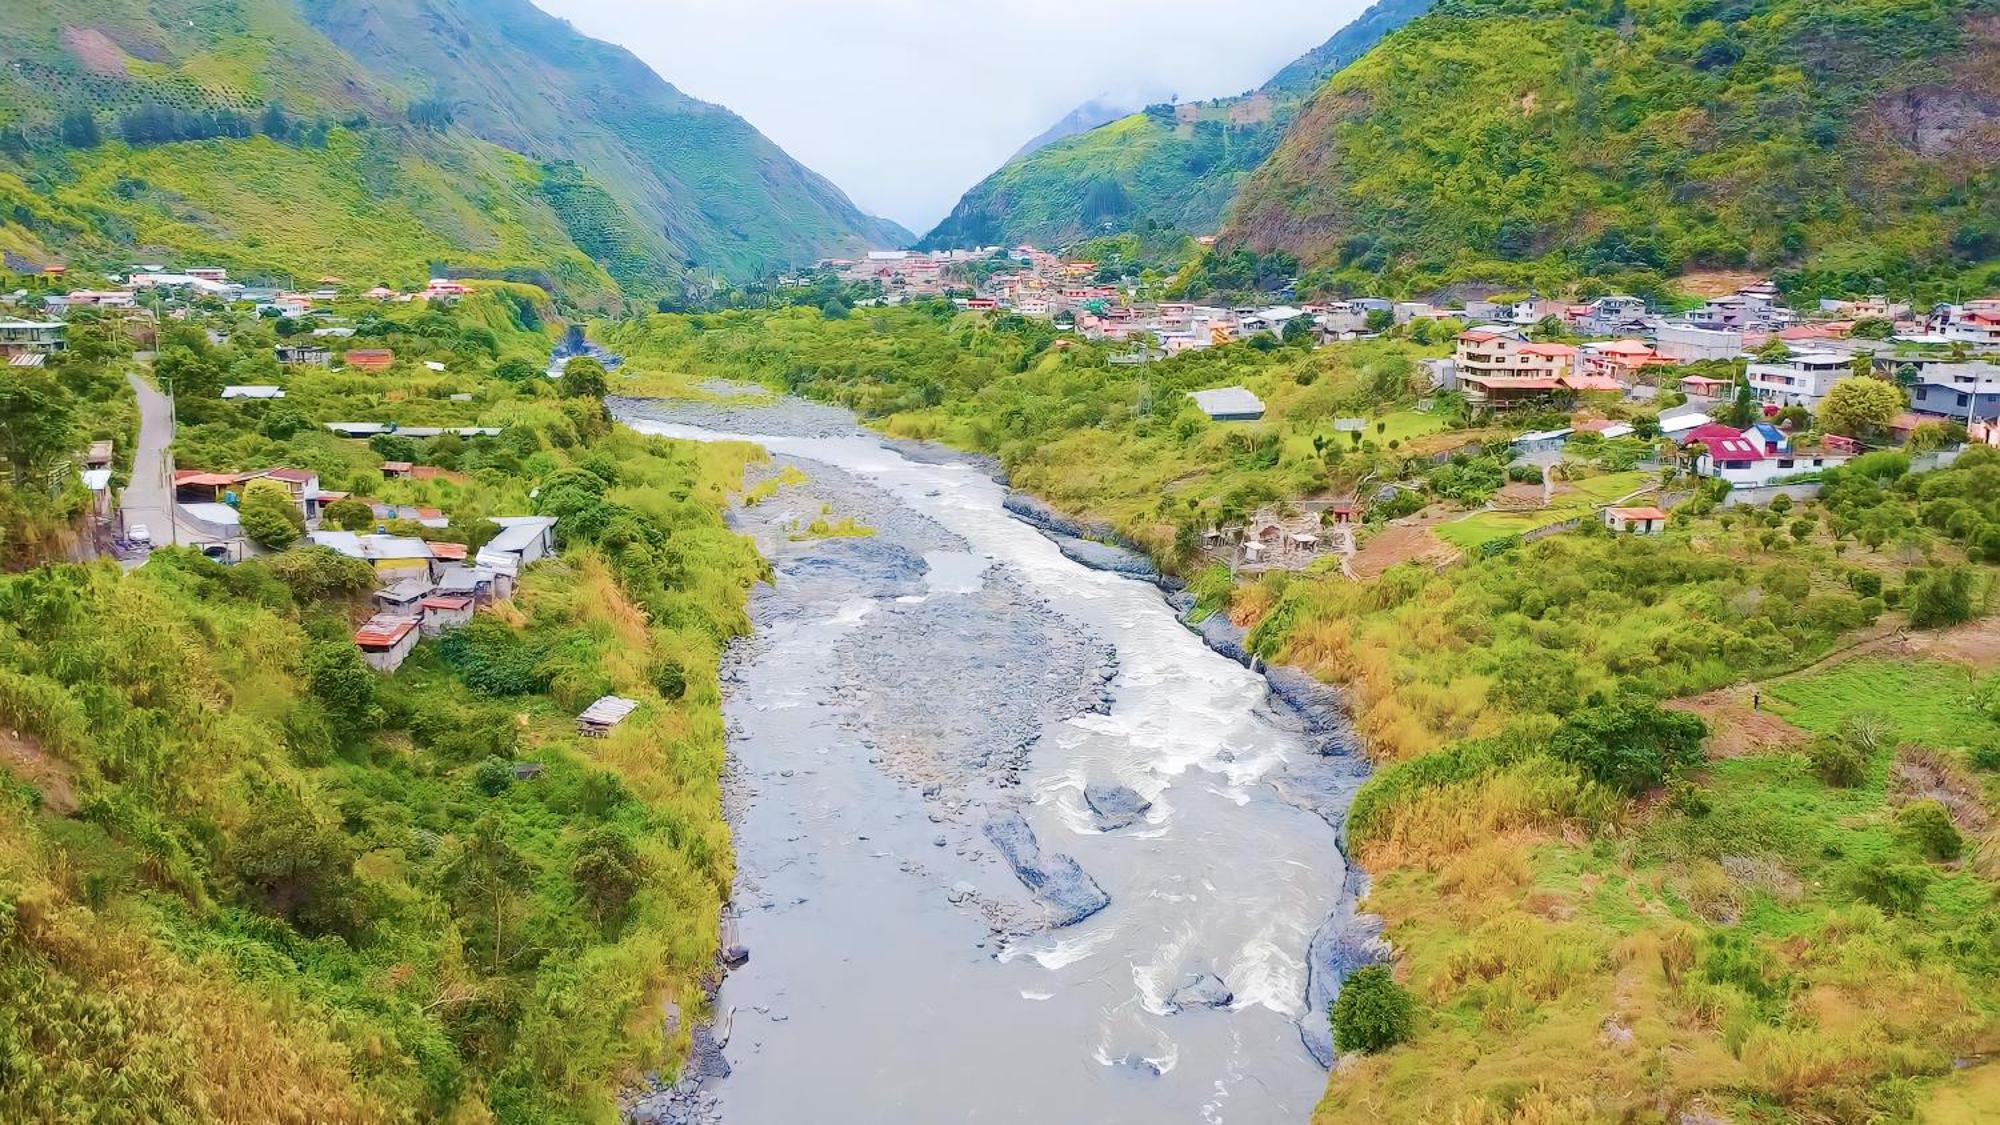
616, 400, 1382, 1125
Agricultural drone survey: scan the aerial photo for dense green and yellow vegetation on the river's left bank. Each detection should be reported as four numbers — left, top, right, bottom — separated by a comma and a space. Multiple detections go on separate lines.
0, 286, 762, 1121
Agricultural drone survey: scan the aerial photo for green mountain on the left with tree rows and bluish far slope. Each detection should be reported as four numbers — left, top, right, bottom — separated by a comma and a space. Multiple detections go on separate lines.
0, 0, 910, 306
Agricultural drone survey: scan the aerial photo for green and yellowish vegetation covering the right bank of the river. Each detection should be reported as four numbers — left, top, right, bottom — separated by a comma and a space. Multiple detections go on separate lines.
604, 304, 2000, 1121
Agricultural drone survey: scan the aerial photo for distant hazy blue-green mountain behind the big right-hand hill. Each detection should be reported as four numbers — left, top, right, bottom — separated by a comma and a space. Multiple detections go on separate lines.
922, 0, 1430, 248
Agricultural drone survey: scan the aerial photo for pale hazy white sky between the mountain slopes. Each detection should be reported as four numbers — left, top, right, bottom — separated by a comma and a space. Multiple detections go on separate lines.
534, 0, 1368, 234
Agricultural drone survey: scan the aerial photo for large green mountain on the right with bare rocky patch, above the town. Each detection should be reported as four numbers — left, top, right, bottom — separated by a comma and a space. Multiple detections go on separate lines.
1218, 0, 2000, 292
